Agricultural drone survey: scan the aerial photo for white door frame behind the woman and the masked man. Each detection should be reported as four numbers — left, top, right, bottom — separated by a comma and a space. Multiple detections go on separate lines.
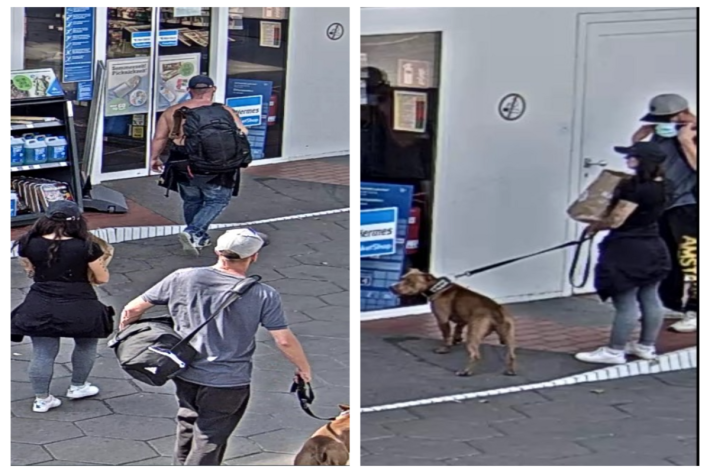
563, 8, 698, 296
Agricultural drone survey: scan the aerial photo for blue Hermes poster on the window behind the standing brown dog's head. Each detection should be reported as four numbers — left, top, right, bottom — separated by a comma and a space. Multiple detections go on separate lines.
360, 182, 414, 311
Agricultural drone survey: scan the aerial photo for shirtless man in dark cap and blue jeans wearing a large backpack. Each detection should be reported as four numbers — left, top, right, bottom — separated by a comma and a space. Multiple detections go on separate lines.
150, 76, 248, 255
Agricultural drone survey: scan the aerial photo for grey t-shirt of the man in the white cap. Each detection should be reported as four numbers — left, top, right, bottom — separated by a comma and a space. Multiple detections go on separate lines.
143, 267, 288, 388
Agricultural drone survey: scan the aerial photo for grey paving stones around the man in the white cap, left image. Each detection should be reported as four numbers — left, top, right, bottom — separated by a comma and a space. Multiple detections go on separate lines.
11, 213, 349, 465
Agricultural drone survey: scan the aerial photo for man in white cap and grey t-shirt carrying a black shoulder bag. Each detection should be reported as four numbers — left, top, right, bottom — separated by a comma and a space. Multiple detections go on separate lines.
121, 229, 311, 465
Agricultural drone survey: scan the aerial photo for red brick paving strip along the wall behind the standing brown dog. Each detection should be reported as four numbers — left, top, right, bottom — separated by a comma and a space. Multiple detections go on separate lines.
361, 314, 698, 353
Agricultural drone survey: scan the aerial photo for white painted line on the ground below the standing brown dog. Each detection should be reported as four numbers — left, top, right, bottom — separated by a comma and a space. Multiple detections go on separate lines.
360, 347, 698, 414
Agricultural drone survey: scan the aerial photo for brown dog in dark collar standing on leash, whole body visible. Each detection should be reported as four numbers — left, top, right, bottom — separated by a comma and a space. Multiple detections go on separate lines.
390, 269, 515, 376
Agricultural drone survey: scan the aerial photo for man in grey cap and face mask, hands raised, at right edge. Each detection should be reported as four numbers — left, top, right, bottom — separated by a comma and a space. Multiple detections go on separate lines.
633, 94, 699, 332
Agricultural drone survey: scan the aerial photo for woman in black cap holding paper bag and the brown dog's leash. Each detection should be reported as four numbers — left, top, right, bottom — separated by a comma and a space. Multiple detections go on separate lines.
576, 143, 671, 364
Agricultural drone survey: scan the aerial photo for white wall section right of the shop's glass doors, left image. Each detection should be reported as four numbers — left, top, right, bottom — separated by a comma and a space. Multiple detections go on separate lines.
282, 8, 350, 158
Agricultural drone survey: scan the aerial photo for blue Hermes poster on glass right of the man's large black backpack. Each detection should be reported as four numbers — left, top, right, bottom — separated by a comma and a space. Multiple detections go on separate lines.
226, 79, 273, 159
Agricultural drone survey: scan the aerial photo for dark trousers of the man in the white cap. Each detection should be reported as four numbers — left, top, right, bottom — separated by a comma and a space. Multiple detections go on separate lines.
173, 379, 250, 466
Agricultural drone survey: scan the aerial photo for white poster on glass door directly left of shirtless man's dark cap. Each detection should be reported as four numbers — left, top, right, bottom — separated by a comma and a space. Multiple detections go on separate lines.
158, 53, 201, 112
